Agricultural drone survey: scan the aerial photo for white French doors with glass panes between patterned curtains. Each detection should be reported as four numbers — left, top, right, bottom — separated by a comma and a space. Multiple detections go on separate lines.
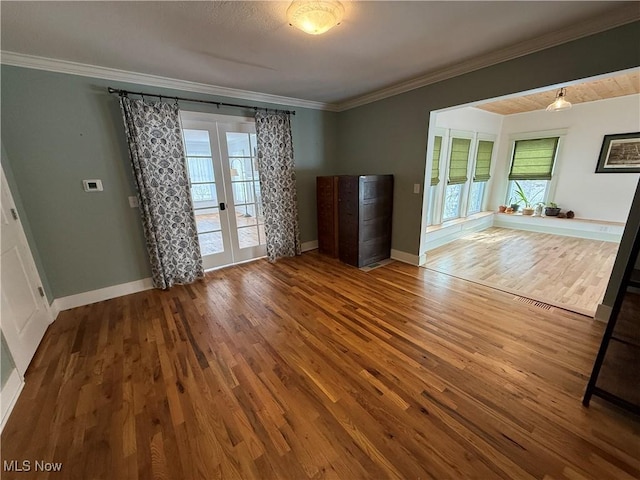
181, 112, 266, 269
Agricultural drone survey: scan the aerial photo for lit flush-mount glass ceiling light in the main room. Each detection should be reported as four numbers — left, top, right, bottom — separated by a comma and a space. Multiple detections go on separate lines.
287, 0, 344, 35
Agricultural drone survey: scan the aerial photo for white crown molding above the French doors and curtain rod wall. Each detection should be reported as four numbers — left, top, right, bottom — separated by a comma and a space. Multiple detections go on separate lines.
0, 50, 337, 112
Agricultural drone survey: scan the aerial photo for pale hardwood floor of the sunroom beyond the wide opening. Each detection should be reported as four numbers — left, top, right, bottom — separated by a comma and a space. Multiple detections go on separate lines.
424, 227, 618, 317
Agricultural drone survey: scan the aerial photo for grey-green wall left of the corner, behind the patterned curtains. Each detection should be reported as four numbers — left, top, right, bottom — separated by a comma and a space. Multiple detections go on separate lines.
1, 65, 336, 298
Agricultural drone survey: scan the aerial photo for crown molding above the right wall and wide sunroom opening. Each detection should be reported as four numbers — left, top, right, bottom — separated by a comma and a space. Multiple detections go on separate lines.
337, 2, 640, 112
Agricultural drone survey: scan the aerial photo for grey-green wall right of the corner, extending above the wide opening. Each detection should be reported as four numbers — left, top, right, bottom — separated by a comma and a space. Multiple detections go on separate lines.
336, 22, 640, 255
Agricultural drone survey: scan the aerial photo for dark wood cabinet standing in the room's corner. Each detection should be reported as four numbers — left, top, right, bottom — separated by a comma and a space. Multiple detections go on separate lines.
318, 175, 393, 267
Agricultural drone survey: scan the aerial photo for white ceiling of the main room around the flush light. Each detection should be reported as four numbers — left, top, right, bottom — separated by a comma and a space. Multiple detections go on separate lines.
0, 0, 640, 106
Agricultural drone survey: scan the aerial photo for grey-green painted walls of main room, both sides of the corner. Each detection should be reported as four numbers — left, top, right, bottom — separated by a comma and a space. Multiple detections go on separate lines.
0, 22, 640, 299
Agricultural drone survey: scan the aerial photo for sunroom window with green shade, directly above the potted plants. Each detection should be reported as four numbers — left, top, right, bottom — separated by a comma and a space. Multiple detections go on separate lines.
507, 137, 560, 205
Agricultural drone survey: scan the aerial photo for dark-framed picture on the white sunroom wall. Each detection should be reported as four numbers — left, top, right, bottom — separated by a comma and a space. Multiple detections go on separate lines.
596, 132, 640, 173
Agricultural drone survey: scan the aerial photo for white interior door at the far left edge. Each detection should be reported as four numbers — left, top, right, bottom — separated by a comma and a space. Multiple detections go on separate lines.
0, 167, 52, 376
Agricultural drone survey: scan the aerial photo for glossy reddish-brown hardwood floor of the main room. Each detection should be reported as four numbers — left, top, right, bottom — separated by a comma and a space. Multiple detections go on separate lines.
2, 253, 640, 480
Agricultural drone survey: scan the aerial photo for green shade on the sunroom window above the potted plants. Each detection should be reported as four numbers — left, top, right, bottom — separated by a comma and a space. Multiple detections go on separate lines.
509, 137, 559, 180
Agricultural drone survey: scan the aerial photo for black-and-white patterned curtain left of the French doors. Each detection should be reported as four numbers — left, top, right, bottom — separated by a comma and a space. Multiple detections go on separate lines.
120, 97, 204, 289
